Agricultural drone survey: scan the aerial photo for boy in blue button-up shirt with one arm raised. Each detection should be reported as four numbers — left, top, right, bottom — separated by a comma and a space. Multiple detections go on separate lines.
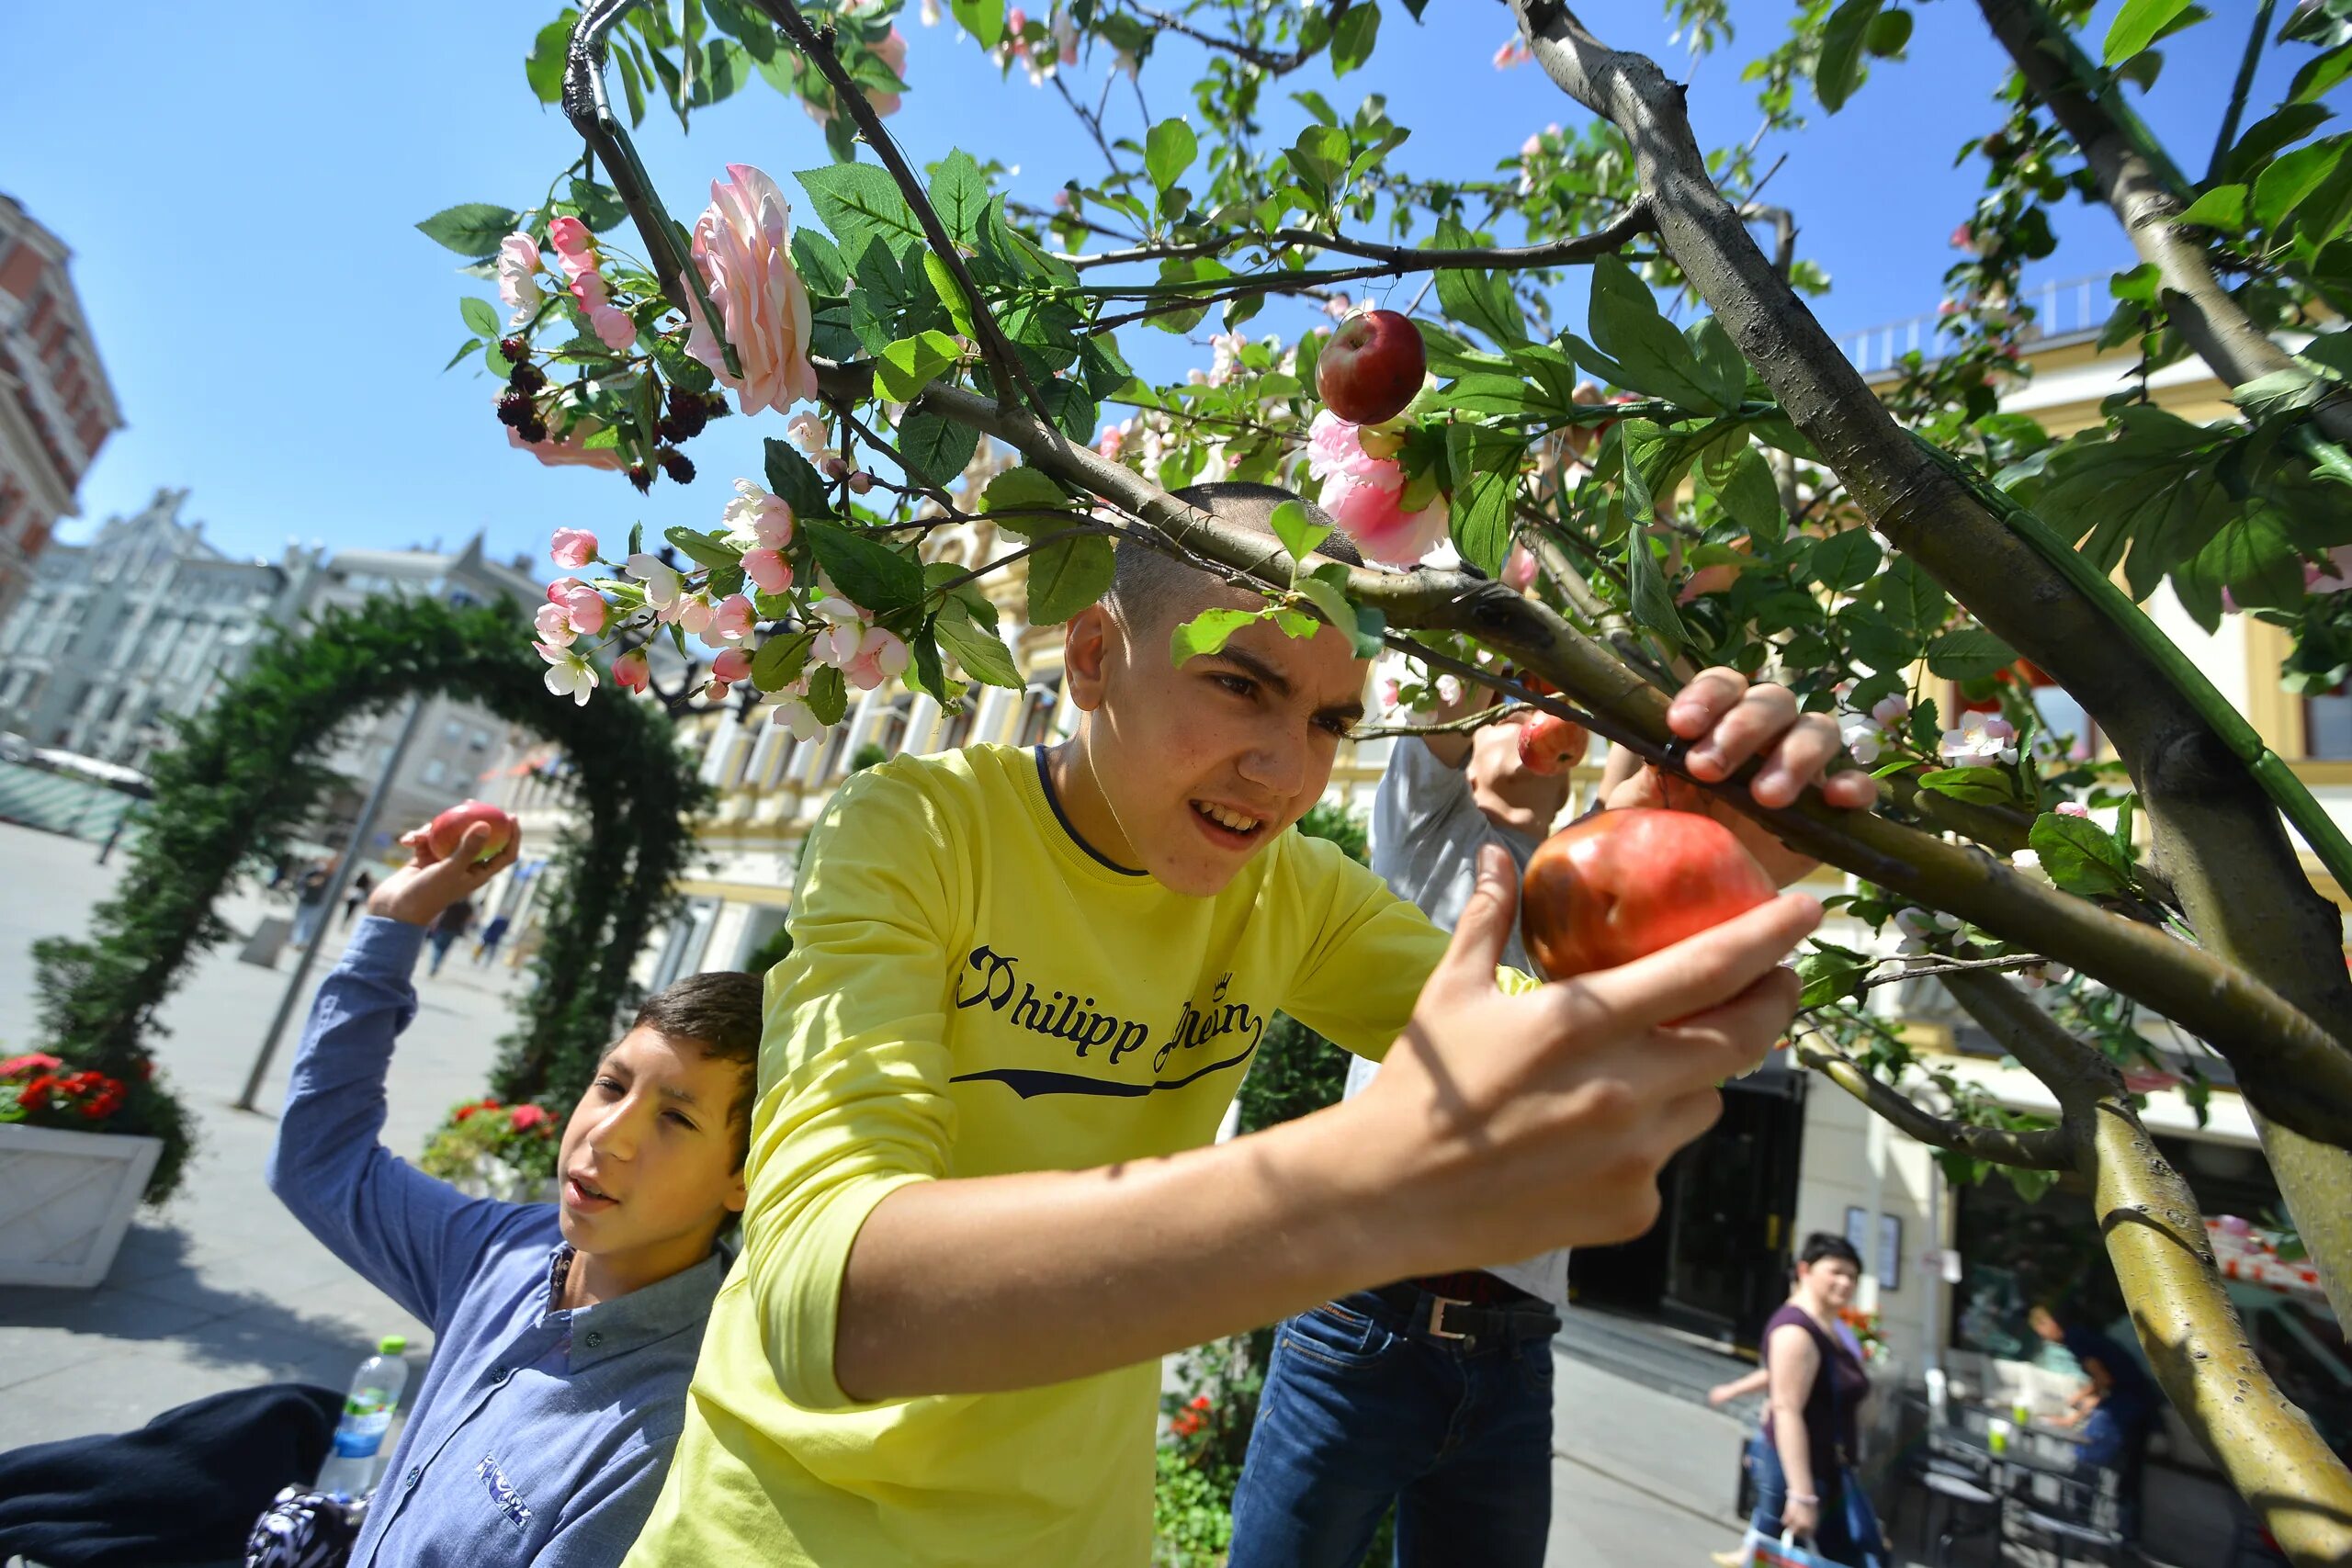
268, 825, 760, 1568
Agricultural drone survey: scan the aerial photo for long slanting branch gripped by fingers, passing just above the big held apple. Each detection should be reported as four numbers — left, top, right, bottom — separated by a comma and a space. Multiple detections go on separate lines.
917, 373, 2352, 1145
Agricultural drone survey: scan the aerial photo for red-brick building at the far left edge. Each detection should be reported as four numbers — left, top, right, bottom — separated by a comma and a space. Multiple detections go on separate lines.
0, 195, 122, 618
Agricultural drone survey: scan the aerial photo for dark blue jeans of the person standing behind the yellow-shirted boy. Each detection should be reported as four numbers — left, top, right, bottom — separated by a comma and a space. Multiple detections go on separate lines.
1227, 1295, 1553, 1568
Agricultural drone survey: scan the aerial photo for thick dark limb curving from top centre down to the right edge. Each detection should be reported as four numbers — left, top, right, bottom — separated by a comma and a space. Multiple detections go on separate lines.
1512, 0, 2352, 1170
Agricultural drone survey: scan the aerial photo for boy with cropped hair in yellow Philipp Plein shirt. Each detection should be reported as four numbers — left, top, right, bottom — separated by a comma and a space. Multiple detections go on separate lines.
628, 484, 1872, 1568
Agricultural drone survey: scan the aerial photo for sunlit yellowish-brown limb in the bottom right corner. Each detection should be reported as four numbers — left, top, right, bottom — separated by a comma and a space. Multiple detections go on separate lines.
1943, 976, 2352, 1568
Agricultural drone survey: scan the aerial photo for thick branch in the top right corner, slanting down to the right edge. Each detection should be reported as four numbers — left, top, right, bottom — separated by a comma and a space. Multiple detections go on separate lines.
1978, 0, 2352, 442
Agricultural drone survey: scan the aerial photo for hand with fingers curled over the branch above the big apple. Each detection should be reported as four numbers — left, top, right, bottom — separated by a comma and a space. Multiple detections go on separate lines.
1601, 665, 1879, 886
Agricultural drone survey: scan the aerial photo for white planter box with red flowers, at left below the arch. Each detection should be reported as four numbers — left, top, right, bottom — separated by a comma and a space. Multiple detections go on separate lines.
0, 1122, 163, 1291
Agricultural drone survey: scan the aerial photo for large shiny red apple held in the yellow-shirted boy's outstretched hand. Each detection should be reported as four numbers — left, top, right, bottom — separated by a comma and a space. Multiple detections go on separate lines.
1520, 807, 1778, 980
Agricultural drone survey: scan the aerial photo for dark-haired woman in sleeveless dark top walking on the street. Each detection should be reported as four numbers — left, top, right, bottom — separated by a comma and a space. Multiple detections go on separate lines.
1750, 1232, 1886, 1568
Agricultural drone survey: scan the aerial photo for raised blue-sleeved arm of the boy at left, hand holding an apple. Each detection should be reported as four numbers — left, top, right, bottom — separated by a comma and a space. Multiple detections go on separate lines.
268, 828, 513, 1324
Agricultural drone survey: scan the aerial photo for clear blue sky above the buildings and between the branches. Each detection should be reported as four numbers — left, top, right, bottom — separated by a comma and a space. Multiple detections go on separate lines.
0, 0, 2305, 571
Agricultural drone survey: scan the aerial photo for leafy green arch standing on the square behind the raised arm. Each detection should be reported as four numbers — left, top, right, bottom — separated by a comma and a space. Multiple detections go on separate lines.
33, 600, 710, 1199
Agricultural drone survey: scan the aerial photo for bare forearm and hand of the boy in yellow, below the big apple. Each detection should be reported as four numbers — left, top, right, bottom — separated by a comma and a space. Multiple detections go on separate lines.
828, 851, 1820, 1401
